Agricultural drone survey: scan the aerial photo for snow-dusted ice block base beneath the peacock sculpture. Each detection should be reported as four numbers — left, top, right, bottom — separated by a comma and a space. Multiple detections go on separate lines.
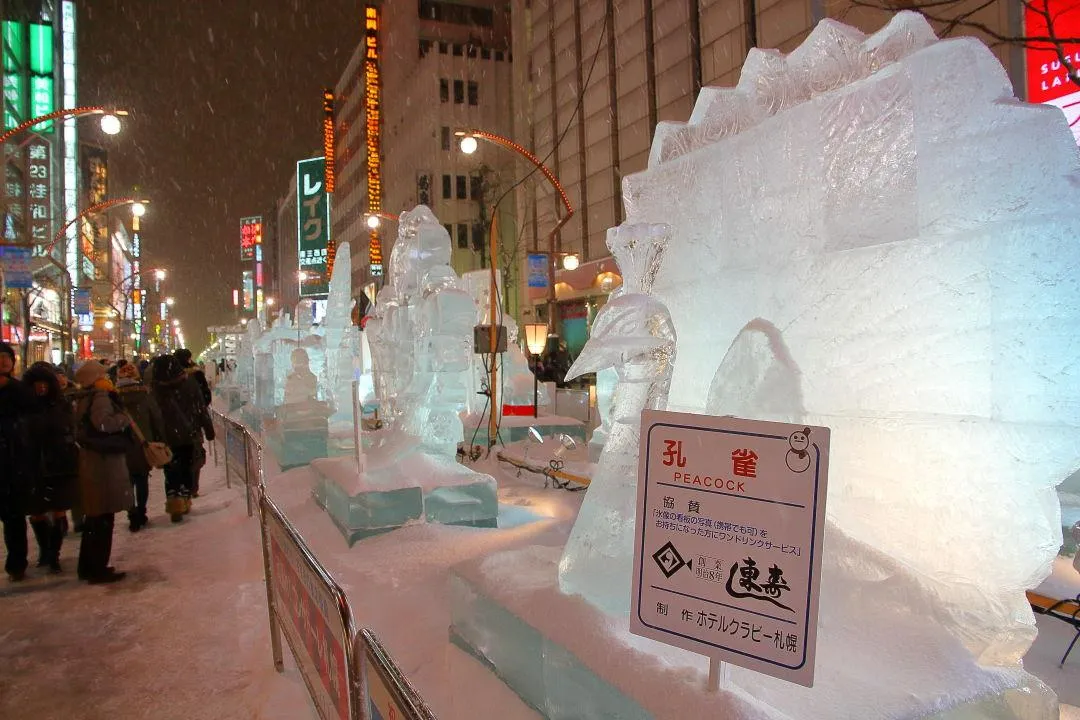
449, 546, 1057, 720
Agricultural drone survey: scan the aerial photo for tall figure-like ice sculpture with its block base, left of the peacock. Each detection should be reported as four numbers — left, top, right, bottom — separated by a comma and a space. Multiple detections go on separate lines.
312, 205, 498, 542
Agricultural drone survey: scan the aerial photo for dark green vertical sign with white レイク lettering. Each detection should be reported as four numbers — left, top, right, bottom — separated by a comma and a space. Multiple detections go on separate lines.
296, 158, 330, 298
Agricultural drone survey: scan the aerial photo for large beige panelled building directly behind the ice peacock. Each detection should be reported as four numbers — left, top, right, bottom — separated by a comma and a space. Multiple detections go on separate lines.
511, 0, 1026, 355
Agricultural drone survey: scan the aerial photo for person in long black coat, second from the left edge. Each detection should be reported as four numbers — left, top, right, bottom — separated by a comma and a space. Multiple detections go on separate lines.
23, 363, 79, 573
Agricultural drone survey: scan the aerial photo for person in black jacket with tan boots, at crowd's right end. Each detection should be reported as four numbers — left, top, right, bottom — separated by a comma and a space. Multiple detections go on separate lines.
150, 355, 214, 522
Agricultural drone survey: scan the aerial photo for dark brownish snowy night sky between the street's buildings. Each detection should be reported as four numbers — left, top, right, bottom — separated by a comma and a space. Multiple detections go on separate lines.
77, 0, 363, 352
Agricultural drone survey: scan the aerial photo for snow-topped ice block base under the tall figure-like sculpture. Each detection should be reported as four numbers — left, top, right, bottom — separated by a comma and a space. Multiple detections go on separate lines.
311, 452, 499, 545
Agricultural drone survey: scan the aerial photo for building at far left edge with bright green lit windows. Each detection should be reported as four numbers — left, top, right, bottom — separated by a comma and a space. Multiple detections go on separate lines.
0, 0, 79, 363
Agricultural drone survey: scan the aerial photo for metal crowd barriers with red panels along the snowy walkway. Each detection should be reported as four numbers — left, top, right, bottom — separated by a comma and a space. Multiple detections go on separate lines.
211, 409, 435, 720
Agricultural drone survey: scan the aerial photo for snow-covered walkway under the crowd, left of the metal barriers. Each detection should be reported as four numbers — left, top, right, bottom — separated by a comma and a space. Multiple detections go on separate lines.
0, 460, 312, 720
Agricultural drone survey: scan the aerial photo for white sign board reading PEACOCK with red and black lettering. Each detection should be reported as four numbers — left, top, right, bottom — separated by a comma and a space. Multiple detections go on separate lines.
630, 410, 829, 687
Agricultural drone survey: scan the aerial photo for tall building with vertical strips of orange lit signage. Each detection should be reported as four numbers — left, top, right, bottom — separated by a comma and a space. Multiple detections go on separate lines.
332, 0, 518, 313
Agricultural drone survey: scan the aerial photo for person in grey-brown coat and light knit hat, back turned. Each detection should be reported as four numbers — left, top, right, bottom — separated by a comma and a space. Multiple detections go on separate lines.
75, 362, 134, 584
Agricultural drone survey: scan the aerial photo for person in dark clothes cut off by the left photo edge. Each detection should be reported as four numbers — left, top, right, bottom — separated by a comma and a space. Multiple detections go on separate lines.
0, 342, 29, 582
